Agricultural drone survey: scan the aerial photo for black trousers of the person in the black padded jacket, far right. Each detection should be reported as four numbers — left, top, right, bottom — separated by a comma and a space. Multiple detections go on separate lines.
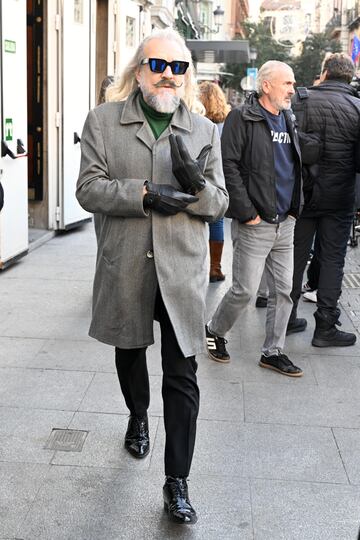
290, 212, 353, 320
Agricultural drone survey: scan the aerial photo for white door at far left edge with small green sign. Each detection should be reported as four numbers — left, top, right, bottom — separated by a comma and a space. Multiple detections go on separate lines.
0, 0, 28, 269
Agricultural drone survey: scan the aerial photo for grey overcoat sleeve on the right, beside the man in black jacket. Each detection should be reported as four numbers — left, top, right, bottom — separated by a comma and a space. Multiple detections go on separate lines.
185, 124, 229, 223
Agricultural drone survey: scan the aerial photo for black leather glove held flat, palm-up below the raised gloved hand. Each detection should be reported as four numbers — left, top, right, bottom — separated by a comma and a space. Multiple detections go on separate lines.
144, 182, 199, 216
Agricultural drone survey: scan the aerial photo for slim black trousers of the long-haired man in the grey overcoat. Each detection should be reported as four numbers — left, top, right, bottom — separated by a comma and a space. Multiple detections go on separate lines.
115, 291, 199, 477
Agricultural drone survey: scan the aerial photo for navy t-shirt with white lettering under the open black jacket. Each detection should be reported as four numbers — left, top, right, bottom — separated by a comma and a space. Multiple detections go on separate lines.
262, 107, 295, 216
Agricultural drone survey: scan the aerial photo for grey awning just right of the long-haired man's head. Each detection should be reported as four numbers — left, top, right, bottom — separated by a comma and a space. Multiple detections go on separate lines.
186, 39, 250, 64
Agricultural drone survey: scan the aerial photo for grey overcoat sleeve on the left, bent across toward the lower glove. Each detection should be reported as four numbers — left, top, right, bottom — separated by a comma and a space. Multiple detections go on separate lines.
76, 110, 148, 218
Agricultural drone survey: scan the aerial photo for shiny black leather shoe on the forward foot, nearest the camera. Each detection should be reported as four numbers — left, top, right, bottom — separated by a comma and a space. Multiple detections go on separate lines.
163, 476, 197, 525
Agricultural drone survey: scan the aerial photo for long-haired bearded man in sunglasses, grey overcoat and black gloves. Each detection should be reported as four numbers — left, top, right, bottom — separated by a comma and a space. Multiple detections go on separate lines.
77, 29, 228, 523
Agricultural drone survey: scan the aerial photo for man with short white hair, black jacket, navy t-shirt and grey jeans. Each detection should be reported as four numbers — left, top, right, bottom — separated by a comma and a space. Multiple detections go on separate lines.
206, 60, 303, 377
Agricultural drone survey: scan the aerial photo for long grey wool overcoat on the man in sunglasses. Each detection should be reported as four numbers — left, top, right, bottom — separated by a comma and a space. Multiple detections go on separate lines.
76, 91, 228, 357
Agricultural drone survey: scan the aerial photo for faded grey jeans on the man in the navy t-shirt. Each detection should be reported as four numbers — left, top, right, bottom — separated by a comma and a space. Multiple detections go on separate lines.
209, 217, 295, 355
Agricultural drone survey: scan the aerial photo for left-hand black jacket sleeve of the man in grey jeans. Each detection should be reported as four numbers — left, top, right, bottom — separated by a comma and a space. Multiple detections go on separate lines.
221, 109, 258, 222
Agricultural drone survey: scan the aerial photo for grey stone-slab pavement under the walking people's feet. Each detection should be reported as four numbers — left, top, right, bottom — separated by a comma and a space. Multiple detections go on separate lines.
0, 220, 360, 540
